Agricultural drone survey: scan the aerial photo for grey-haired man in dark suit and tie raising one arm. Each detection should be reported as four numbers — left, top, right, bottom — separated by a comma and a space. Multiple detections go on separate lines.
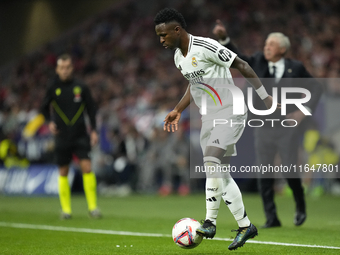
213, 20, 322, 228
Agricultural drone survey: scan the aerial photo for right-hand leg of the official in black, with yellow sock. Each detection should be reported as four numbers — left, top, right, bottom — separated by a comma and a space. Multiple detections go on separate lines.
74, 137, 102, 218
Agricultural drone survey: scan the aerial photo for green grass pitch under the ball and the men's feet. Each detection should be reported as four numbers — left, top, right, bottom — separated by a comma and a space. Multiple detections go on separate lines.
0, 194, 340, 255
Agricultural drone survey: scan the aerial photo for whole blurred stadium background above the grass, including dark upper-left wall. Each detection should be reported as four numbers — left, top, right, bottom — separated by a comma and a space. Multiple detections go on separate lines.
0, 0, 340, 196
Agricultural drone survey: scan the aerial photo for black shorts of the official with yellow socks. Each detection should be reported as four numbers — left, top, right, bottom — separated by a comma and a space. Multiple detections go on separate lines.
55, 135, 91, 166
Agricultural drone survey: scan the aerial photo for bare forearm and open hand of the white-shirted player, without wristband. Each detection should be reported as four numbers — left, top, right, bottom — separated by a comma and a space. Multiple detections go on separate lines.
164, 84, 191, 132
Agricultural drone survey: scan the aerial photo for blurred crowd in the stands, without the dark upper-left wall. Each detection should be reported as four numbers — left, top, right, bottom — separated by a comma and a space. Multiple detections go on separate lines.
0, 0, 340, 195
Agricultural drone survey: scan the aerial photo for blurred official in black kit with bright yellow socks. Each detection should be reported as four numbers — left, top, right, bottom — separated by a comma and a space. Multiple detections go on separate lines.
41, 54, 102, 219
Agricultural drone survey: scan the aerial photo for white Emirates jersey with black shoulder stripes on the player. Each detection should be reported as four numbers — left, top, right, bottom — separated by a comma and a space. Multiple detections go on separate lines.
174, 35, 246, 121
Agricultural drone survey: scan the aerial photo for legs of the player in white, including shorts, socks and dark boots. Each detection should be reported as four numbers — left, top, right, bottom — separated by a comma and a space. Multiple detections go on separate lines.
198, 115, 257, 245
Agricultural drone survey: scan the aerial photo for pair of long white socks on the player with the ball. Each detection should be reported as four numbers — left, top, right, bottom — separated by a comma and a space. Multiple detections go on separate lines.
203, 157, 250, 227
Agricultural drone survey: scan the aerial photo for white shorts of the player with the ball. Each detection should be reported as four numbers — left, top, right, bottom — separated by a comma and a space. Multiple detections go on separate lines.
200, 113, 247, 157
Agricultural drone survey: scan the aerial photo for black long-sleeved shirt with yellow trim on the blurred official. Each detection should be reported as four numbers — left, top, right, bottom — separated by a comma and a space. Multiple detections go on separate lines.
41, 77, 96, 141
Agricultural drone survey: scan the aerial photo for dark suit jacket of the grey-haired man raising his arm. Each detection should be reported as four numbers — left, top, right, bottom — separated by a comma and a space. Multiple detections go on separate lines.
224, 42, 322, 125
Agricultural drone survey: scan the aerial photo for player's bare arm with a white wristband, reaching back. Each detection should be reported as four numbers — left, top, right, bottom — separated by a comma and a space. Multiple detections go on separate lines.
231, 57, 279, 109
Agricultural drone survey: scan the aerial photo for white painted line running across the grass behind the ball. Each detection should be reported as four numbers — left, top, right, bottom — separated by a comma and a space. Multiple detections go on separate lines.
0, 222, 340, 250
